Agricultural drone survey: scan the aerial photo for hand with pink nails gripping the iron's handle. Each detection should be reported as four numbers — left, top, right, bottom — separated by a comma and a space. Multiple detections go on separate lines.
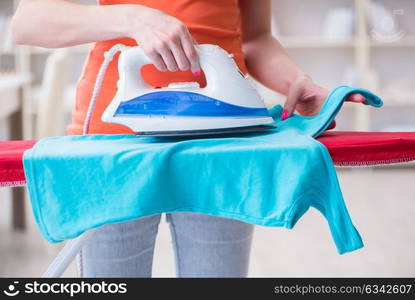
127, 5, 200, 75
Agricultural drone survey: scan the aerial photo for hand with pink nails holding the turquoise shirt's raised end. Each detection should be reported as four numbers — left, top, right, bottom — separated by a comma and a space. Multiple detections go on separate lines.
281, 74, 365, 129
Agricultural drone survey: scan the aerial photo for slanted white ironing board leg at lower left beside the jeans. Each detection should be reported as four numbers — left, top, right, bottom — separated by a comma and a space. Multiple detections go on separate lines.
42, 229, 95, 278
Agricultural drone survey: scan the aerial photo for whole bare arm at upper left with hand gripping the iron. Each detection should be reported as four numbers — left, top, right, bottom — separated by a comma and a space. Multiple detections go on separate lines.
12, 0, 200, 73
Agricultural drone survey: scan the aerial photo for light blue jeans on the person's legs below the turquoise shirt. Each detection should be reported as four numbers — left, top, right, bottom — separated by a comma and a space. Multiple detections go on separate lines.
77, 212, 254, 277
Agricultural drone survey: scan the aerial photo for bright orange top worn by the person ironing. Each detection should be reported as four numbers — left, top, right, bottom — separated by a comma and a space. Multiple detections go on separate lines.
67, 0, 246, 135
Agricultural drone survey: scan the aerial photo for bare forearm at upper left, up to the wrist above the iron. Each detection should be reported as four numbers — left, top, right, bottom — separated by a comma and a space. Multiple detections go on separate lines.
12, 0, 135, 48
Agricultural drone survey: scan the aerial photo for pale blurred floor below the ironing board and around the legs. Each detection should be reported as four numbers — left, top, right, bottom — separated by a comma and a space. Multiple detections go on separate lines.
0, 168, 415, 277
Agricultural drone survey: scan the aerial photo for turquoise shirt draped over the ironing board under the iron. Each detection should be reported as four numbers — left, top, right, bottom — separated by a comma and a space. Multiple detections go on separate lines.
23, 86, 382, 254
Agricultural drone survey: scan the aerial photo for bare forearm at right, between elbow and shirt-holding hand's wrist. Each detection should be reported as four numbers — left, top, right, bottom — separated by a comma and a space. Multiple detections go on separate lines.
243, 33, 306, 95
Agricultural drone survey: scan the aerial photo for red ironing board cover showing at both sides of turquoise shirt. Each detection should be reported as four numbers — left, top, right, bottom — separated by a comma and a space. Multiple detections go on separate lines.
0, 131, 415, 186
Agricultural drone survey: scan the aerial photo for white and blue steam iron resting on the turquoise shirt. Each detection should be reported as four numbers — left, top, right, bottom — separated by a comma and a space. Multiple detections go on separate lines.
102, 44, 275, 136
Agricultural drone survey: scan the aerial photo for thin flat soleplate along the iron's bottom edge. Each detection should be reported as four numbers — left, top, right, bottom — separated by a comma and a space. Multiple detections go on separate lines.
136, 125, 276, 137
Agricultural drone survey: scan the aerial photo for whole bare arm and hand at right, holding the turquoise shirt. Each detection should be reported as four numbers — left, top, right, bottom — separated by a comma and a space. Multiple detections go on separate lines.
239, 0, 364, 119
